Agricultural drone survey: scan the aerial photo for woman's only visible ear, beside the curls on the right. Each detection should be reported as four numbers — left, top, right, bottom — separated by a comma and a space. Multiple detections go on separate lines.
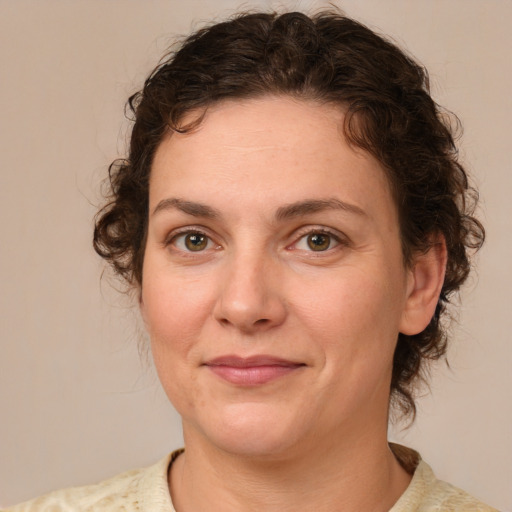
400, 235, 447, 335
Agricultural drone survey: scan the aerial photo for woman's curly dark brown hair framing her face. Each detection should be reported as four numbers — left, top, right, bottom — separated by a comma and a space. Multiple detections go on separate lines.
94, 11, 484, 417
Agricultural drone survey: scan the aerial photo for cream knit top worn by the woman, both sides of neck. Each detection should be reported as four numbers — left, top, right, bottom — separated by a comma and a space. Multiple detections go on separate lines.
4, 445, 498, 512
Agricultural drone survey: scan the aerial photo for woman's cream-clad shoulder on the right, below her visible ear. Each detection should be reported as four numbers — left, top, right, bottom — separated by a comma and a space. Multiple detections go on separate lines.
390, 444, 498, 512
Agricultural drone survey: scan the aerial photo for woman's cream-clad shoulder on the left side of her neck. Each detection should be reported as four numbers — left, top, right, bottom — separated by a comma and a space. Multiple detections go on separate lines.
4, 452, 179, 512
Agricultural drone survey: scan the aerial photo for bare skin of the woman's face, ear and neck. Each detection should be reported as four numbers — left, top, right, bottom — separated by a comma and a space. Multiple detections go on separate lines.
141, 97, 446, 512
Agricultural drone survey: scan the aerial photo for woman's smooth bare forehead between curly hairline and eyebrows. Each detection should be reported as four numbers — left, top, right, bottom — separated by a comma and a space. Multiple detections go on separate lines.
150, 97, 396, 222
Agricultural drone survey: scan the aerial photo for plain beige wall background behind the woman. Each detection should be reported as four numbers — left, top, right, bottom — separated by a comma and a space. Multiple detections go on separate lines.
0, 0, 512, 511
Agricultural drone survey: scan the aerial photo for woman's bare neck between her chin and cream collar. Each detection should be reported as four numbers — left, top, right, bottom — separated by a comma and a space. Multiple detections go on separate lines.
169, 420, 411, 512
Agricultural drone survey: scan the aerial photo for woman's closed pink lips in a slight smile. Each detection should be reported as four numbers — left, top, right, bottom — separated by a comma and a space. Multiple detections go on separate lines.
204, 355, 306, 387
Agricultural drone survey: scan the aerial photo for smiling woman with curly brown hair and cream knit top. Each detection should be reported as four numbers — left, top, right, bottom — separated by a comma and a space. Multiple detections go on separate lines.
7, 8, 493, 512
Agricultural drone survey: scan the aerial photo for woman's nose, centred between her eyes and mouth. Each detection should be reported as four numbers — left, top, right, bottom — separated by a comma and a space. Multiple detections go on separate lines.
214, 256, 287, 334
